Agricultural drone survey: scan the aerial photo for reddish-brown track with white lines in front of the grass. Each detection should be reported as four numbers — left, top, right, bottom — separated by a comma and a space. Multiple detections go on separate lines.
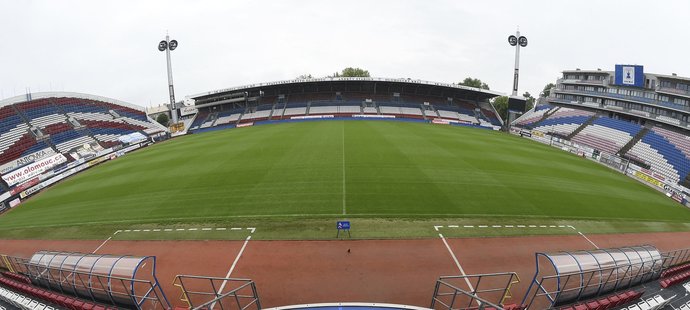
0, 232, 690, 307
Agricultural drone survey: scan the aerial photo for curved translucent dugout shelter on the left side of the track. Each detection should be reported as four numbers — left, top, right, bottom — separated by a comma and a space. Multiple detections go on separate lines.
22, 251, 170, 309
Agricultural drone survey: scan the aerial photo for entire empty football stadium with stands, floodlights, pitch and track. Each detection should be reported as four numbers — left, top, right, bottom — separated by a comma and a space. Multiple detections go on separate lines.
0, 0, 690, 310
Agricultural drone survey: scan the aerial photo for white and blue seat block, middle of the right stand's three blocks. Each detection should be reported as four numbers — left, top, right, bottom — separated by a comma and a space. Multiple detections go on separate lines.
571, 117, 642, 154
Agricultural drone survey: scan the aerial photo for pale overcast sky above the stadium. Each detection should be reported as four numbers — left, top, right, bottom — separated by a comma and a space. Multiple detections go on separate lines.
0, 0, 690, 106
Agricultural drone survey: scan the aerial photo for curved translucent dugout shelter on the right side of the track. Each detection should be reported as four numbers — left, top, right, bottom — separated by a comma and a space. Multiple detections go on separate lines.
522, 245, 664, 308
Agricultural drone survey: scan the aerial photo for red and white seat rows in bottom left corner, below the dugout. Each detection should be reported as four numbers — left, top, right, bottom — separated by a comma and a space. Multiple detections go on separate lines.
0, 278, 116, 310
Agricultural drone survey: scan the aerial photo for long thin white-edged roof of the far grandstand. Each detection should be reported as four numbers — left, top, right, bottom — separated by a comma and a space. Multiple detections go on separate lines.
189, 77, 506, 99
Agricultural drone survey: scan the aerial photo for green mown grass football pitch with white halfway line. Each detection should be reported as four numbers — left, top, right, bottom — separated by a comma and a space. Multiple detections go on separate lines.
0, 121, 690, 238
